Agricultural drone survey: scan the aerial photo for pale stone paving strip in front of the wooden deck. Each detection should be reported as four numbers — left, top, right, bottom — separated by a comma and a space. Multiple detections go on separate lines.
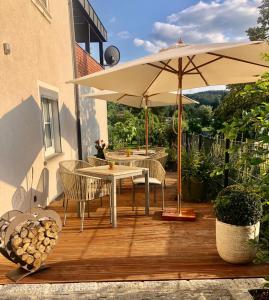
0, 278, 264, 300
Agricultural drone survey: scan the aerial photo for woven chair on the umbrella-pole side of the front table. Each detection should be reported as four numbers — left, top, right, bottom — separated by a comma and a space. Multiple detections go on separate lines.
133, 159, 165, 209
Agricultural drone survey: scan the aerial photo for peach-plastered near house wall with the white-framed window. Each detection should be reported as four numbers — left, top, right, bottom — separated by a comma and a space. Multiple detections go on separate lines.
0, 0, 107, 215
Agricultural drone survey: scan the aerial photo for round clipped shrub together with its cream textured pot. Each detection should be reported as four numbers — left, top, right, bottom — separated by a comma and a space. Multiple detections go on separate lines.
214, 185, 262, 264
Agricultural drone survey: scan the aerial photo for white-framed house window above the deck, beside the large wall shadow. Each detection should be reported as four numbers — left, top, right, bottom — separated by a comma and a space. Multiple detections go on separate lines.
40, 88, 62, 157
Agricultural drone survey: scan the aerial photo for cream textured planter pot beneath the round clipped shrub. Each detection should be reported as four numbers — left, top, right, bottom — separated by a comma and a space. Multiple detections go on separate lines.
216, 220, 260, 264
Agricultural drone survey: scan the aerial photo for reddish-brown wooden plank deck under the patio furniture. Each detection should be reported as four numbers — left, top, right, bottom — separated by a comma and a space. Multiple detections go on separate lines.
0, 174, 269, 284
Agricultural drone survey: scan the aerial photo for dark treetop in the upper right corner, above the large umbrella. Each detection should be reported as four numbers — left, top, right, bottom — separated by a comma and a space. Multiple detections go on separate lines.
246, 0, 269, 41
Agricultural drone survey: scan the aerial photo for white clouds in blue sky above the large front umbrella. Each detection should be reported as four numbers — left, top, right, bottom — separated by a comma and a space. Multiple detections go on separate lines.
134, 0, 261, 52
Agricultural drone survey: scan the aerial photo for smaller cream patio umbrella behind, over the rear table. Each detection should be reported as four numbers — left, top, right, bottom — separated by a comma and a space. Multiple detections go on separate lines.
84, 90, 198, 155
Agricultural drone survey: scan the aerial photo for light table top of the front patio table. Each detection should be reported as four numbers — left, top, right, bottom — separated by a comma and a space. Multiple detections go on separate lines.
77, 165, 145, 176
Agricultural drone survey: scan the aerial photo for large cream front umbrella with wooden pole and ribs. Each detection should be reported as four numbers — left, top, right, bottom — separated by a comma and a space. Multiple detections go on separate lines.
70, 41, 269, 220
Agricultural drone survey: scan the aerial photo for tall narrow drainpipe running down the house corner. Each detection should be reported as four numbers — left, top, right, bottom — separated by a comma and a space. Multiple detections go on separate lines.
68, 0, 82, 159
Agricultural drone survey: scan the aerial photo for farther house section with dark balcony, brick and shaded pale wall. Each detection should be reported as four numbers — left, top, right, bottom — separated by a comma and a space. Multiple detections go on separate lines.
73, 0, 108, 158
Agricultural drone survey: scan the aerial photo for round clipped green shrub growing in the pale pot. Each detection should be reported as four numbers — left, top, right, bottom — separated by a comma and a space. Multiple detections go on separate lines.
214, 185, 262, 226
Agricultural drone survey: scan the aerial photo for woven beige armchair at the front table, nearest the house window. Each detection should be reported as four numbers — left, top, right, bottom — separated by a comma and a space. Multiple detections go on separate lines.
60, 168, 112, 231
